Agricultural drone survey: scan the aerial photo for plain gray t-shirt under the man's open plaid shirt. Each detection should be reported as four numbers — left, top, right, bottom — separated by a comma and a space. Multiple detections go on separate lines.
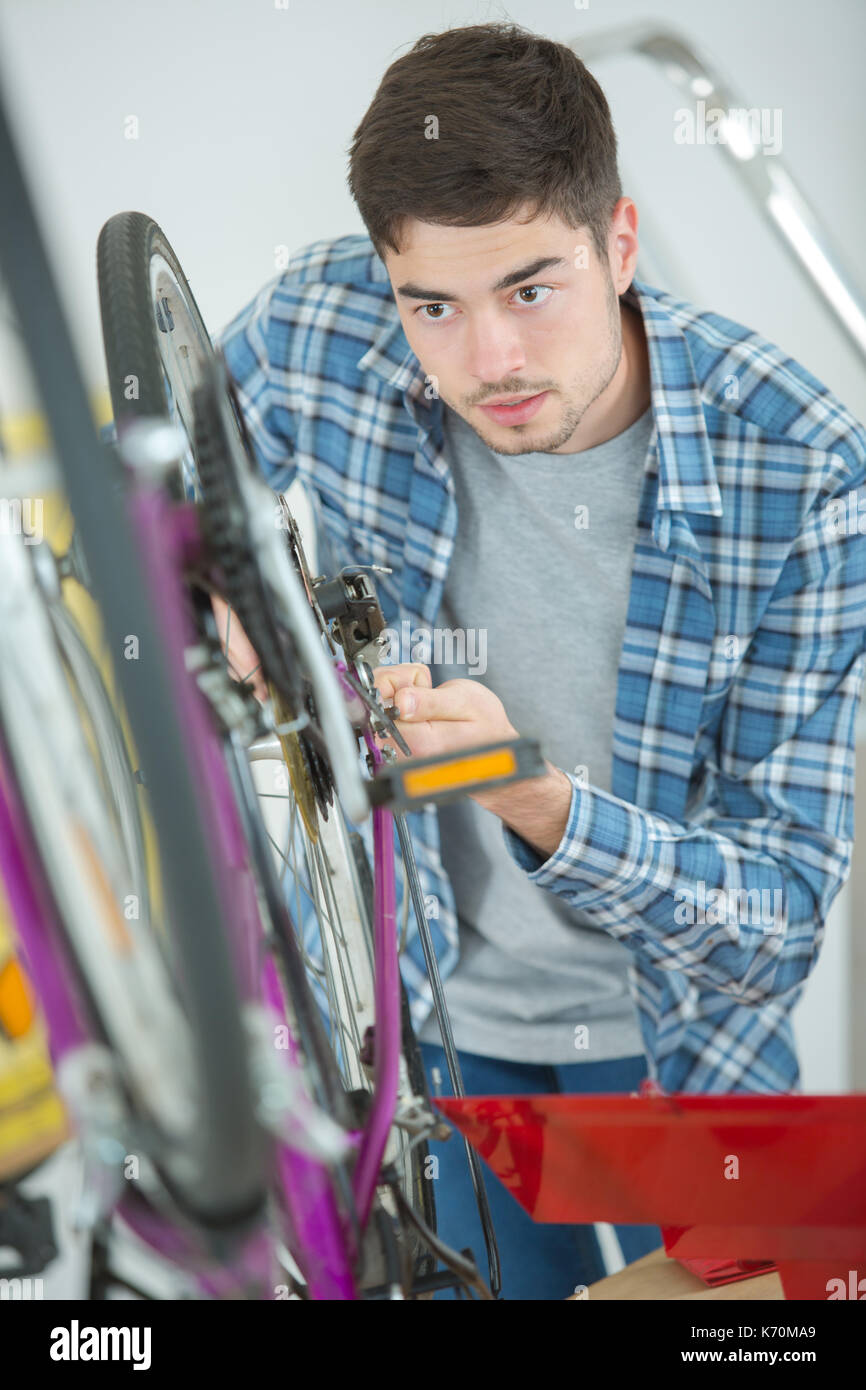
420, 407, 653, 1063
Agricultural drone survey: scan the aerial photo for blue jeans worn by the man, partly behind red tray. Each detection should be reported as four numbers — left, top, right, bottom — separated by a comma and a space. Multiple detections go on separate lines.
420, 1043, 663, 1300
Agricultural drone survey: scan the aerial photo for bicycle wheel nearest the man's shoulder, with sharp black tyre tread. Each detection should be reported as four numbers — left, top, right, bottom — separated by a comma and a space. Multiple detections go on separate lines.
97, 202, 435, 1278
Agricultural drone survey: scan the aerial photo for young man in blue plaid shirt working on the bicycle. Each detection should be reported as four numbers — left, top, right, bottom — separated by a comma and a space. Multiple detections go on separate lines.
215, 24, 866, 1298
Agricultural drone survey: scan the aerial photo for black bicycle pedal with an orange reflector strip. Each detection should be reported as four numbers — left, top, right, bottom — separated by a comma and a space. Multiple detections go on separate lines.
370, 735, 546, 810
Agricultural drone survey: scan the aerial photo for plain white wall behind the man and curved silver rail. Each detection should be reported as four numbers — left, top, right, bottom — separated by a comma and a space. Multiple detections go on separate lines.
0, 0, 866, 1090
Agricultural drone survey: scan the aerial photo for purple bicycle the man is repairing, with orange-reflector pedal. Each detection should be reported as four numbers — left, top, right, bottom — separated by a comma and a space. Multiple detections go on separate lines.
0, 73, 544, 1300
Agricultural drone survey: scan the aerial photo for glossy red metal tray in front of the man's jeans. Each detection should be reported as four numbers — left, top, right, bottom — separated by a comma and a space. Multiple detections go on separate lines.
436, 1084, 866, 1300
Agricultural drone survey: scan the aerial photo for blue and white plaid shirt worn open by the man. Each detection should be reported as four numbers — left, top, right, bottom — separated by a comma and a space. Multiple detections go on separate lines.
220, 235, 866, 1093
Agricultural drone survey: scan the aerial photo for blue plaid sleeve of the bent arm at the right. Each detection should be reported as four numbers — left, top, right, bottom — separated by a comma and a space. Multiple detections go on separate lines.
502, 491, 866, 1004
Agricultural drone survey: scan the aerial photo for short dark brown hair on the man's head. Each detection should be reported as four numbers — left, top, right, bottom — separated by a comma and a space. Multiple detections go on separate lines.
349, 24, 623, 265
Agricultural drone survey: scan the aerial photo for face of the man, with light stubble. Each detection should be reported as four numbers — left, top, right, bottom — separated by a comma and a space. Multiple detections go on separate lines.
385, 205, 631, 455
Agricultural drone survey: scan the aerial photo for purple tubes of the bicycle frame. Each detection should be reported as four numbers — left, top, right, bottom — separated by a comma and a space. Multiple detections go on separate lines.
0, 488, 400, 1300
